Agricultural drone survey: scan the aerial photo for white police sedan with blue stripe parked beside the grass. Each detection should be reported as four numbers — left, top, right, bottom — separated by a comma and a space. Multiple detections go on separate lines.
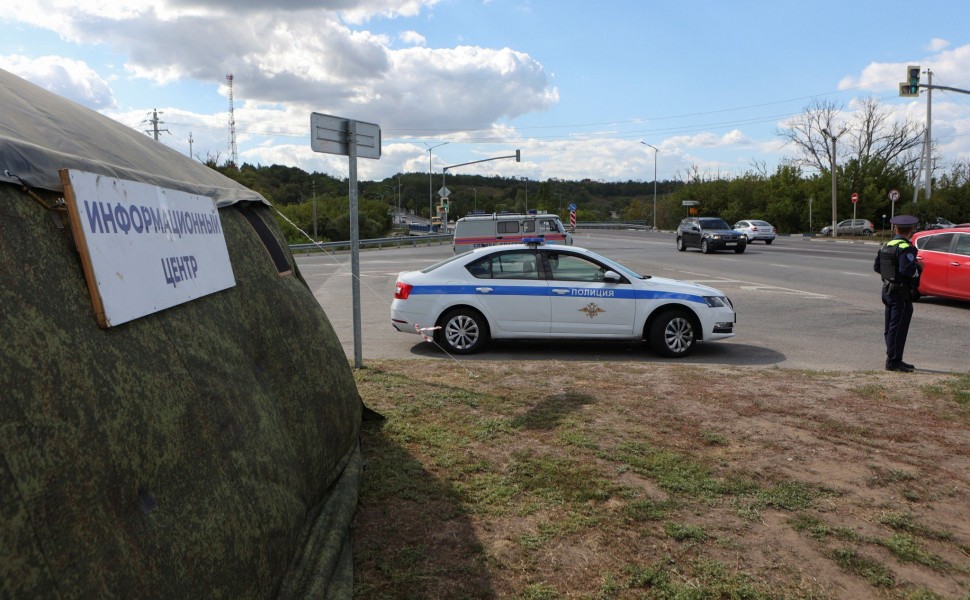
391, 239, 736, 357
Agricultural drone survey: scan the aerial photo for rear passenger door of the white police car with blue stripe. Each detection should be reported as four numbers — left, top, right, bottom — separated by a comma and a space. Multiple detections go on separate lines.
467, 249, 549, 337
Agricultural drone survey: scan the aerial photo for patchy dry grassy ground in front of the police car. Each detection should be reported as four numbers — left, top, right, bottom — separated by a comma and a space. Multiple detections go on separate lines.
354, 360, 970, 600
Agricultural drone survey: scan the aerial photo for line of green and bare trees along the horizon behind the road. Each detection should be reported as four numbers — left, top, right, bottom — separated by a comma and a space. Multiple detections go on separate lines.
209, 99, 970, 243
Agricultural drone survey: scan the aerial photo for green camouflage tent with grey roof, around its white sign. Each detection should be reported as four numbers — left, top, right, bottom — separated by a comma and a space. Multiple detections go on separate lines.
0, 70, 363, 599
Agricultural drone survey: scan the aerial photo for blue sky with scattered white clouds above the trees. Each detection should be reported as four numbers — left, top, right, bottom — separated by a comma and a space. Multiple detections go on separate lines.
0, 0, 970, 181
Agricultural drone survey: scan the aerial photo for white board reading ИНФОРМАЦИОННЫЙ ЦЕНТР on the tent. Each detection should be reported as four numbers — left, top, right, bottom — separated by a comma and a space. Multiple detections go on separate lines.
61, 170, 236, 328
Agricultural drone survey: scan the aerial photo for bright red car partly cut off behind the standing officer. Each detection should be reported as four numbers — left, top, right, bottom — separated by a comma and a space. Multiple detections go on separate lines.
913, 223, 970, 300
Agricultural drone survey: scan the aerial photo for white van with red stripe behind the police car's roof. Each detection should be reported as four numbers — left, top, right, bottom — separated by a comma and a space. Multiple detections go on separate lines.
453, 213, 573, 254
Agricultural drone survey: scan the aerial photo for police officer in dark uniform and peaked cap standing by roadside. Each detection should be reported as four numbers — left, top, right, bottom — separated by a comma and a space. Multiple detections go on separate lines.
873, 215, 919, 373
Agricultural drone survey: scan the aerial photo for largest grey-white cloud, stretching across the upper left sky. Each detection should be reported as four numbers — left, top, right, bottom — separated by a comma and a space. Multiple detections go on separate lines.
5, 0, 559, 136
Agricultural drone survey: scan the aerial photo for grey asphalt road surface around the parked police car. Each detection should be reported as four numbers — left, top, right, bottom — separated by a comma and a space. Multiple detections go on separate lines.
297, 231, 970, 372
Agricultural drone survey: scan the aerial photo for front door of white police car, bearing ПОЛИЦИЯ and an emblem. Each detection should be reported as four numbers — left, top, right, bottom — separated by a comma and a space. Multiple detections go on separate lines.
542, 250, 637, 337
